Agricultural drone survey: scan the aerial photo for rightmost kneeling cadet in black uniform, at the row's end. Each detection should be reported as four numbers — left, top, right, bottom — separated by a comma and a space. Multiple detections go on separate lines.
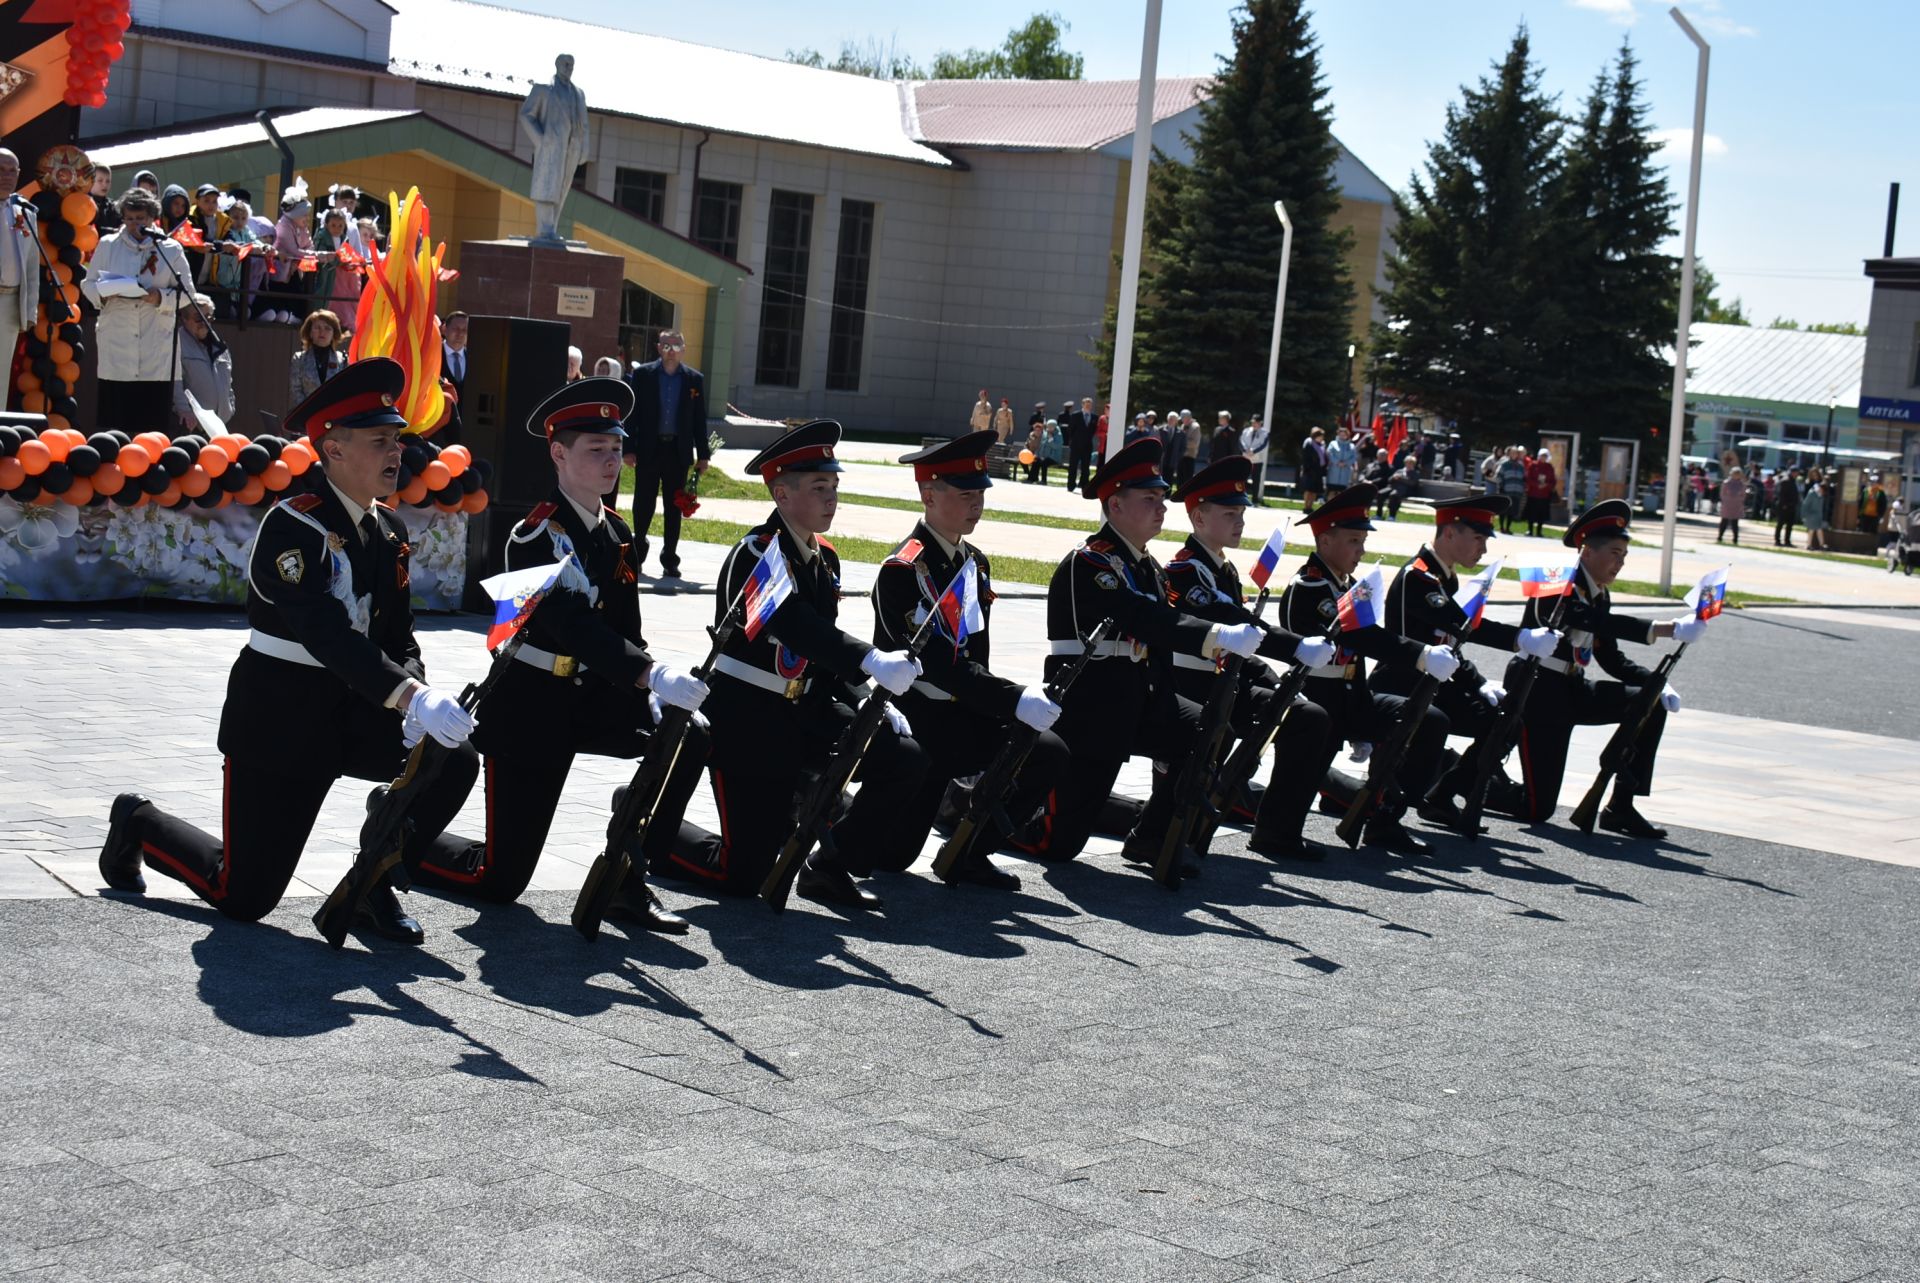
1519, 499, 1707, 837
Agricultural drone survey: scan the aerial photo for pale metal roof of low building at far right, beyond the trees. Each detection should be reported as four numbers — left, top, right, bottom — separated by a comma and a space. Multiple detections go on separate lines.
1668, 323, 1866, 407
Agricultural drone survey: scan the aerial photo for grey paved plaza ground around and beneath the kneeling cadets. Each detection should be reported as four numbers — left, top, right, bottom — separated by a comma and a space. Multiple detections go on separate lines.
0, 545, 1920, 1283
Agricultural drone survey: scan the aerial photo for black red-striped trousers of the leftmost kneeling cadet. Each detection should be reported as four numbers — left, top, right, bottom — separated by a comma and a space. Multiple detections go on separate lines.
129, 741, 480, 922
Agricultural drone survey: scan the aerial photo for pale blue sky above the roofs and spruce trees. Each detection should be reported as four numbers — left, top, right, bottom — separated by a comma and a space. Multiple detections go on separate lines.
511, 0, 1920, 325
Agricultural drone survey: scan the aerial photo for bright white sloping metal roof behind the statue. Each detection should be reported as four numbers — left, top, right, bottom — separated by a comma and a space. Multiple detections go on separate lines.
388, 0, 952, 167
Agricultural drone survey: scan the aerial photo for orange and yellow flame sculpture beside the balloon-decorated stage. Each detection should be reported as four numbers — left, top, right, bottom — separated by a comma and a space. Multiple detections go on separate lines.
348, 186, 453, 436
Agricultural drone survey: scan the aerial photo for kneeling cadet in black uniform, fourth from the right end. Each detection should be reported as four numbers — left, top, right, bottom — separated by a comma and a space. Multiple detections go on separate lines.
1167, 455, 1332, 859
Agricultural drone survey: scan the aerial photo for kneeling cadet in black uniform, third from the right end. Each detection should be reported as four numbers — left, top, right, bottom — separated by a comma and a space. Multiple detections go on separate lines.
1281, 486, 1459, 855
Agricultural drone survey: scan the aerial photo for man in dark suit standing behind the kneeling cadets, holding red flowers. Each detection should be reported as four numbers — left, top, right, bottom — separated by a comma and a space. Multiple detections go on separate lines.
626, 330, 712, 578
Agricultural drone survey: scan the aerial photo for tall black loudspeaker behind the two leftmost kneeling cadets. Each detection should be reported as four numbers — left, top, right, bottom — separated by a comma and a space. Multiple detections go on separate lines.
461, 317, 572, 613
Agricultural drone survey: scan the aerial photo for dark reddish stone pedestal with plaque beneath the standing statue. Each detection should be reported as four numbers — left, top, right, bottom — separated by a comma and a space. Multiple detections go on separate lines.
461, 240, 626, 364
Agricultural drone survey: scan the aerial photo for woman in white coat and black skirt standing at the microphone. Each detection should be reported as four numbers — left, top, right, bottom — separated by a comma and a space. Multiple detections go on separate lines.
81, 186, 194, 434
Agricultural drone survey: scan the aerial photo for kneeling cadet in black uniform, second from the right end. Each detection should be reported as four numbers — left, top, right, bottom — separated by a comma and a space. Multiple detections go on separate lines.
1373, 494, 1559, 826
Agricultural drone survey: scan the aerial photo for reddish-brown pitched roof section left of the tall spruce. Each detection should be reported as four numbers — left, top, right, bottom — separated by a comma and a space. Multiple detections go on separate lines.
904, 77, 1212, 152
